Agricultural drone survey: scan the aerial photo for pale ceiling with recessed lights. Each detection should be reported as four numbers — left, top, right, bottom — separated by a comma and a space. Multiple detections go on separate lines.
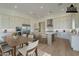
0, 3, 79, 19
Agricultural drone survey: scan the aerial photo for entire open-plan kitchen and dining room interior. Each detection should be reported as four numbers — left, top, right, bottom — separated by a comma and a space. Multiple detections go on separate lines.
0, 3, 79, 56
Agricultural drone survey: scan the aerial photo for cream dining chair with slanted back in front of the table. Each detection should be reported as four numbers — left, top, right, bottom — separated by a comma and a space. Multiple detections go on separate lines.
18, 40, 39, 56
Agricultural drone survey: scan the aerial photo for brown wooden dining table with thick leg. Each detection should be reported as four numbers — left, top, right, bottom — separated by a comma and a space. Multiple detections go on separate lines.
5, 36, 28, 56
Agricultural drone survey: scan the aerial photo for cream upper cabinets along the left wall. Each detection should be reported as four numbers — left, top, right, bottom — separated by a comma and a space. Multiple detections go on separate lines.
0, 14, 30, 28
